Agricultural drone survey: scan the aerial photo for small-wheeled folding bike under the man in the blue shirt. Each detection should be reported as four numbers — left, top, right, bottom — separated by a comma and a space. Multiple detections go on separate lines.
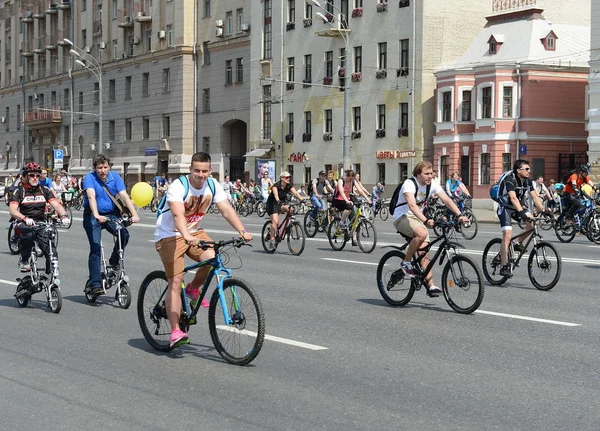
83, 218, 131, 309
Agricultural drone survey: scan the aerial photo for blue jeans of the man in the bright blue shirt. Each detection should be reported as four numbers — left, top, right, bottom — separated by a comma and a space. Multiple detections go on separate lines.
83, 211, 129, 287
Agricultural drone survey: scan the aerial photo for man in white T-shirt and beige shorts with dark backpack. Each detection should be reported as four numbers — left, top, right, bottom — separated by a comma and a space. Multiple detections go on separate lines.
390, 160, 468, 298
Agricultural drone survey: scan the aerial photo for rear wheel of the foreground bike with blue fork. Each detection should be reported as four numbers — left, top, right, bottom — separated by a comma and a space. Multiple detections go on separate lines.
137, 271, 173, 352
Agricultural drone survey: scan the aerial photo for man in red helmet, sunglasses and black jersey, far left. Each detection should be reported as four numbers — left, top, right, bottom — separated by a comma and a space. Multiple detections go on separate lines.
9, 162, 69, 274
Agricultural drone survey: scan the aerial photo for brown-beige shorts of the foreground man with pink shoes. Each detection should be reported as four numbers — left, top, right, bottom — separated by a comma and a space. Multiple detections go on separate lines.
154, 229, 212, 278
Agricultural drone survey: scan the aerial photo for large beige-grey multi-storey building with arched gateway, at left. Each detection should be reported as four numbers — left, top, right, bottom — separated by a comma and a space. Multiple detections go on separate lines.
0, 0, 250, 183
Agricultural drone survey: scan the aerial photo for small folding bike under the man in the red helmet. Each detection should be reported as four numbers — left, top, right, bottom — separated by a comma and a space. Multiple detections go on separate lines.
14, 219, 62, 314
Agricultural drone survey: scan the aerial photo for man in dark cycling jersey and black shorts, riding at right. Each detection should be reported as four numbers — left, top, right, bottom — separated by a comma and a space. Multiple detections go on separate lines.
498, 159, 544, 277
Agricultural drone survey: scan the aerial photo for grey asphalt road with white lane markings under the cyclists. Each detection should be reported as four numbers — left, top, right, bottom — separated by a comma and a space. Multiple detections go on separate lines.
0, 211, 600, 431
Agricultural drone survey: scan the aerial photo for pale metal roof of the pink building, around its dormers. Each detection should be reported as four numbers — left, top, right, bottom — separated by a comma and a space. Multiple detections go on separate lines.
438, 19, 591, 71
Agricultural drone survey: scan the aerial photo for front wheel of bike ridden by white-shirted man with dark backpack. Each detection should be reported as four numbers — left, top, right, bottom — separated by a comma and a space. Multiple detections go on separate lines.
442, 254, 485, 314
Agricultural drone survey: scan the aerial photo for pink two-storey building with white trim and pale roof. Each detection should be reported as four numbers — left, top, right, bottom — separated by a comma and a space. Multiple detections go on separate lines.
433, 7, 590, 198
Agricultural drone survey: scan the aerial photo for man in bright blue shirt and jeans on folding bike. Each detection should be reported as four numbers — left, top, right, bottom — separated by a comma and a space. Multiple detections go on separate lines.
83, 154, 140, 295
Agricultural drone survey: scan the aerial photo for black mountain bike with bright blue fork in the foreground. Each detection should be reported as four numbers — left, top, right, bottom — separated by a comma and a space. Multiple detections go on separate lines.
137, 238, 265, 365
